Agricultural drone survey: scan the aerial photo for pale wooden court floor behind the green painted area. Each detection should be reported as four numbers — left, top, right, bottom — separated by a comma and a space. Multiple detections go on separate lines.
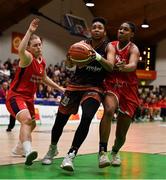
0, 121, 166, 166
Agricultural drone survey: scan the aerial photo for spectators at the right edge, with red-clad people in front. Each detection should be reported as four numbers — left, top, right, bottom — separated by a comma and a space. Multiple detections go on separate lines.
135, 86, 166, 121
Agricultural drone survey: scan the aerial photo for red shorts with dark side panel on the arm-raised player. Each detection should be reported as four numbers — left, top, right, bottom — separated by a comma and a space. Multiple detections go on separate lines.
6, 96, 35, 118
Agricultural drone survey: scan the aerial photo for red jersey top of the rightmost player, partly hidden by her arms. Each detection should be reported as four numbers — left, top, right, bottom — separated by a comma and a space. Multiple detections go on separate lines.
105, 41, 137, 85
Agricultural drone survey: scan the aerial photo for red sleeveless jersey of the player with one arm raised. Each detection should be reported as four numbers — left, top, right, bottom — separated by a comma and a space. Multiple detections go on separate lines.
7, 57, 46, 99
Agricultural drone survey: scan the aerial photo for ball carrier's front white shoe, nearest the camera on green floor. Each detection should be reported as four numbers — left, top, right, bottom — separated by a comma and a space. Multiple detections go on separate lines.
60, 151, 76, 171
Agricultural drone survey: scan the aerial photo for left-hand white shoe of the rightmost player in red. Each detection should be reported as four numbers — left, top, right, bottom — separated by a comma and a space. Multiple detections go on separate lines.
99, 151, 111, 168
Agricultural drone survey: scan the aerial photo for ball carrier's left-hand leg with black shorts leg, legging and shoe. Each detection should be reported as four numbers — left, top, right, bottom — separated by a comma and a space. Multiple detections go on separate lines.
42, 91, 80, 165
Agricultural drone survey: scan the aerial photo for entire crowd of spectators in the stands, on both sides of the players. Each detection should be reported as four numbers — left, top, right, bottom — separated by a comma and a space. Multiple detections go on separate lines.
0, 59, 166, 121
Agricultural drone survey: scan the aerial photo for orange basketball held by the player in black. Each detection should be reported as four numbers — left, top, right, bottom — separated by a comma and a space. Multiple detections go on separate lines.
68, 42, 93, 64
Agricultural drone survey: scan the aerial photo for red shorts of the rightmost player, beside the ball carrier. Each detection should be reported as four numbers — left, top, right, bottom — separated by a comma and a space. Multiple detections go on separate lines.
105, 84, 140, 118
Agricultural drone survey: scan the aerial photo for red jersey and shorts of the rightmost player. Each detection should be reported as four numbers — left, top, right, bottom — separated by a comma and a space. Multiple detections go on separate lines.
104, 41, 139, 117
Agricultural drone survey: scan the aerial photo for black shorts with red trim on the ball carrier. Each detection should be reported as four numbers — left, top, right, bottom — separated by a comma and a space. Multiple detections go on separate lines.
58, 90, 101, 114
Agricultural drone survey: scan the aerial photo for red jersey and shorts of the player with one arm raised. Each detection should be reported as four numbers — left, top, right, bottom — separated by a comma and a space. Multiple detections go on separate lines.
6, 58, 46, 117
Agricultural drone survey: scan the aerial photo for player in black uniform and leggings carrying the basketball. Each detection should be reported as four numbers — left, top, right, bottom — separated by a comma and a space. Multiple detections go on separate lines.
42, 18, 115, 171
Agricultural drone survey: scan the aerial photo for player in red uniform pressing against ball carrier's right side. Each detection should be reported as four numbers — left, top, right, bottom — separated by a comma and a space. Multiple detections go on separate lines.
99, 22, 140, 167
